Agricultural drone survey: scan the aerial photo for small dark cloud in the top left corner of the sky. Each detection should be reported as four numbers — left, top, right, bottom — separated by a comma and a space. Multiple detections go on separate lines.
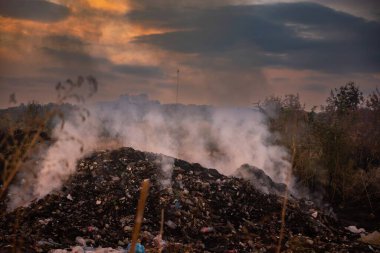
0, 0, 70, 22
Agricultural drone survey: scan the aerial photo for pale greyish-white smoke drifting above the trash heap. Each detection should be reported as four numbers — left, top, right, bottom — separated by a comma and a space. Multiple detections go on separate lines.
27, 95, 290, 201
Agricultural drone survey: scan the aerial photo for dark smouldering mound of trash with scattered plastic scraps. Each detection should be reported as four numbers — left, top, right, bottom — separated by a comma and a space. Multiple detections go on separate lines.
0, 148, 380, 253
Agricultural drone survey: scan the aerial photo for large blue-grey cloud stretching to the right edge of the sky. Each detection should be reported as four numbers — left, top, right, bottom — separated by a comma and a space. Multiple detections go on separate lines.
128, 3, 380, 73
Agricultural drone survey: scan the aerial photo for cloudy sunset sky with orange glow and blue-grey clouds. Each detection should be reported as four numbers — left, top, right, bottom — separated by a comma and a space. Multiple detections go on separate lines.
0, 0, 380, 107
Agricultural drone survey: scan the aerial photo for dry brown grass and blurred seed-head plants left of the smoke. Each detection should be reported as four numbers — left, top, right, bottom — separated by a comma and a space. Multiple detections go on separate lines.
0, 76, 97, 208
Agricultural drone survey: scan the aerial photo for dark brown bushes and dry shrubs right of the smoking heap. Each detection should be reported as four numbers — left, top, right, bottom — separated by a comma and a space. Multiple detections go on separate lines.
263, 82, 380, 215
